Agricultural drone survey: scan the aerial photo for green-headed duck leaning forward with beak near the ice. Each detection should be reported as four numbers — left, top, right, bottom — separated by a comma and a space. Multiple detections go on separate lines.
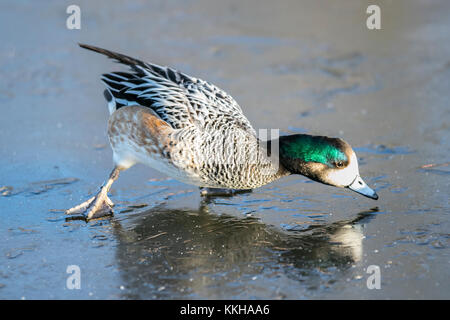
65, 43, 378, 220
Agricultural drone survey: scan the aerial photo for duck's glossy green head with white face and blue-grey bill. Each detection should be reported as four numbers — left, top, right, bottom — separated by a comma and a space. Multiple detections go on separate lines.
279, 134, 378, 200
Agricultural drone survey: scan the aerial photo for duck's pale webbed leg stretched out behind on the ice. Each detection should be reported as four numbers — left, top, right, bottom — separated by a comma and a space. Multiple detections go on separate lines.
65, 166, 123, 220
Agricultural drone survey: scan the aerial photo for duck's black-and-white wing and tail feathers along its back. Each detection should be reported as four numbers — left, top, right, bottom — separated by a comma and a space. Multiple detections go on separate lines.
80, 44, 256, 135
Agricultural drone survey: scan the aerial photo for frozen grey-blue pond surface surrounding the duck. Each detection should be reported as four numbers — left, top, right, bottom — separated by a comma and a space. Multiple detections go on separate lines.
0, 0, 450, 299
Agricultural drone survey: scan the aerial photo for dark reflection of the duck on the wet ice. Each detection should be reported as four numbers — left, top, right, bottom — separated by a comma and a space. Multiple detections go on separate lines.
109, 207, 372, 299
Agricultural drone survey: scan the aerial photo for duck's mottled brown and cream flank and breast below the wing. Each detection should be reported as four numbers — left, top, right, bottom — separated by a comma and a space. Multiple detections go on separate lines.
108, 106, 289, 189
